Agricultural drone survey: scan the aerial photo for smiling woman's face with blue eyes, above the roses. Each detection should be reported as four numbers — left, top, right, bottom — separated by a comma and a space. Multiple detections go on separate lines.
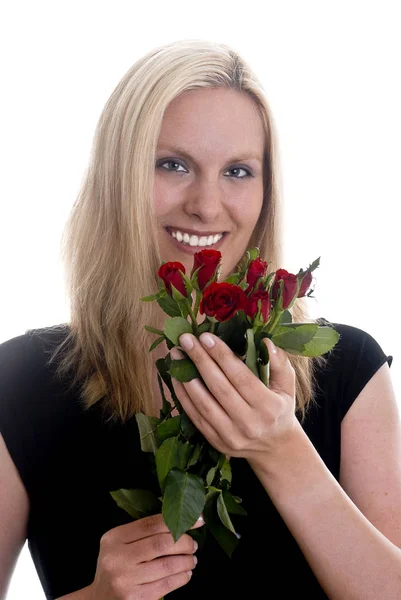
154, 88, 265, 281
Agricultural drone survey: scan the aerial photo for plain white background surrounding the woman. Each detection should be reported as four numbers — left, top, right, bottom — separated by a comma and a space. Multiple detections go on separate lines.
0, 0, 401, 600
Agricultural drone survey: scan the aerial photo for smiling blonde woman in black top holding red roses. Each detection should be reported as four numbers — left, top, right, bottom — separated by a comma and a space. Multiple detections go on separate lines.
0, 41, 401, 600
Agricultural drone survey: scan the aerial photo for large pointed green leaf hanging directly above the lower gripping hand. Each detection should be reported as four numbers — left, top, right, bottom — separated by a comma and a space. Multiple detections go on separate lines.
162, 469, 206, 542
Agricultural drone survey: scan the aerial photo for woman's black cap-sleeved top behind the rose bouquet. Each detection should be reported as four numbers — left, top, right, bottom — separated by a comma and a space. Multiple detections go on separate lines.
0, 323, 392, 599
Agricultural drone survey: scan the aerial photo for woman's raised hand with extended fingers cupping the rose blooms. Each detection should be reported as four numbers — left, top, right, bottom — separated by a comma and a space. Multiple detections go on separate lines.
171, 333, 299, 460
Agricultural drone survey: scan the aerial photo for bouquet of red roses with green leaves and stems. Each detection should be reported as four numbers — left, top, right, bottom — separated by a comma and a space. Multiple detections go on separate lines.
110, 248, 339, 556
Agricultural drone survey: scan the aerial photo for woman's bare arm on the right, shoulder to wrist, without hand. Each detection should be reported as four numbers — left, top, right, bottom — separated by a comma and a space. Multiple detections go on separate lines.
249, 364, 401, 600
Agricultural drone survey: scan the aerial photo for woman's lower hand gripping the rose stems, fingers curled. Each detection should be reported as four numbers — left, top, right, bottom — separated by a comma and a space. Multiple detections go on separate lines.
87, 514, 204, 600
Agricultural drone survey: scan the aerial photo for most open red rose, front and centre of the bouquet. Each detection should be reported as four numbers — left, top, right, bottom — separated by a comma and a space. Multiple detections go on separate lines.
199, 281, 248, 322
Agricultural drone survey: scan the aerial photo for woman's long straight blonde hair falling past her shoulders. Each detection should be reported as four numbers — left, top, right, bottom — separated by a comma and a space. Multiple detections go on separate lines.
37, 40, 326, 422
